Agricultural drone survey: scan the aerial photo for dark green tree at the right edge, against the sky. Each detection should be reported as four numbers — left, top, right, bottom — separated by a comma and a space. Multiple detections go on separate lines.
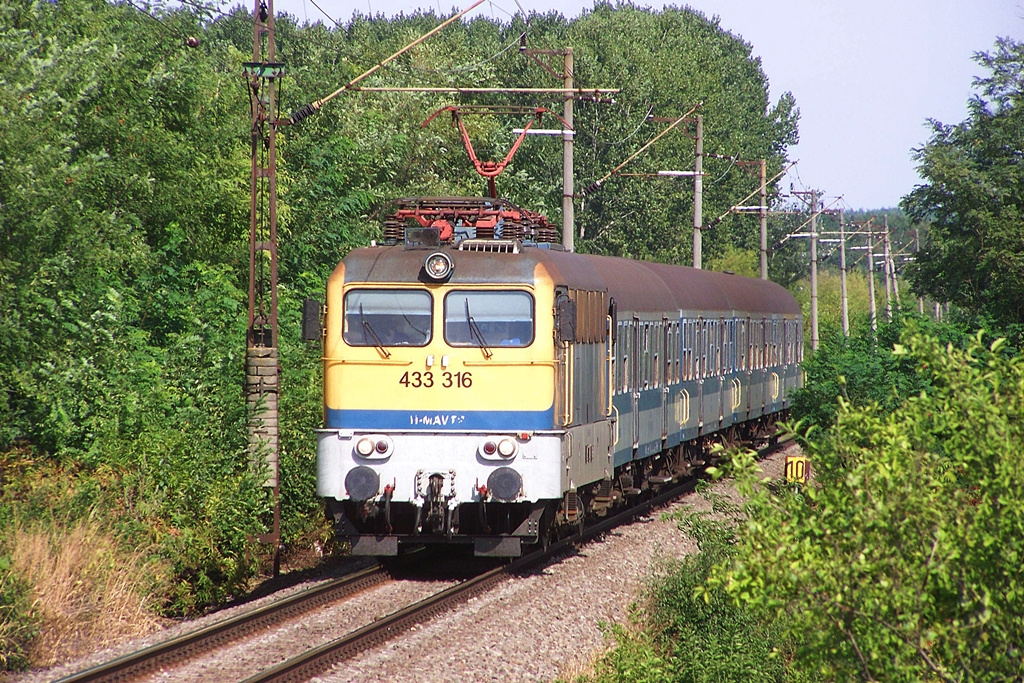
903, 38, 1024, 338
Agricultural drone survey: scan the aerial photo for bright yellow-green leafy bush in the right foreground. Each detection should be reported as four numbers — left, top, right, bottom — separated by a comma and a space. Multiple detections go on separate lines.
710, 333, 1024, 681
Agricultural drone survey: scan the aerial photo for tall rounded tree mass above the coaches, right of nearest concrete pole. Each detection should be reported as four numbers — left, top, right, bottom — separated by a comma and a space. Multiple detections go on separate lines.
566, 4, 799, 263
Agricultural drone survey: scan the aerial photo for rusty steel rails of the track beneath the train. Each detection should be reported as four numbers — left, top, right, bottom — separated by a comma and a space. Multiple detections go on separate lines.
57, 442, 785, 683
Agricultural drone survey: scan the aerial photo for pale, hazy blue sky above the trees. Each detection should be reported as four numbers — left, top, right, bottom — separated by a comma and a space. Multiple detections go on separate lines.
262, 0, 1024, 209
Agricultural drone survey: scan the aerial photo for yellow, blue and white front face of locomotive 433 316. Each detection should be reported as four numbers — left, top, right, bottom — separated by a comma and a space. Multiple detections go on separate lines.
317, 240, 562, 555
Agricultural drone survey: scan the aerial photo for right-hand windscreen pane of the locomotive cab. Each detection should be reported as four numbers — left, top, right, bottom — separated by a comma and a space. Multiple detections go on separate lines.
444, 290, 534, 347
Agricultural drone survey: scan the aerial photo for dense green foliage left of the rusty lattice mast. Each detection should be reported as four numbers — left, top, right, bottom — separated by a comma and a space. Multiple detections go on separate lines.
0, 1, 266, 611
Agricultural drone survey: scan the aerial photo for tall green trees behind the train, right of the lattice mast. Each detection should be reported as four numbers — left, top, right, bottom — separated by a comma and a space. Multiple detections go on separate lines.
268, 3, 798, 276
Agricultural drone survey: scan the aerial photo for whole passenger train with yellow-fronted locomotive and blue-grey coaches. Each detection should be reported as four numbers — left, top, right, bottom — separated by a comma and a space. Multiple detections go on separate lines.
303, 198, 803, 557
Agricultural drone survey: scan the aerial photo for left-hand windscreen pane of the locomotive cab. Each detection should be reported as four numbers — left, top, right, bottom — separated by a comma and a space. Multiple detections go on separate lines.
342, 289, 431, 346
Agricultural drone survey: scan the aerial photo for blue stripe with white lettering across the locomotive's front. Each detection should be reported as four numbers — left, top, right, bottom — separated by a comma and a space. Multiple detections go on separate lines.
326, 405, 555, 431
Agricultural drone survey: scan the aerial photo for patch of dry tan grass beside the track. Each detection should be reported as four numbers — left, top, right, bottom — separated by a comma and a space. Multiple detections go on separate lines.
6, 520, 161, 667
